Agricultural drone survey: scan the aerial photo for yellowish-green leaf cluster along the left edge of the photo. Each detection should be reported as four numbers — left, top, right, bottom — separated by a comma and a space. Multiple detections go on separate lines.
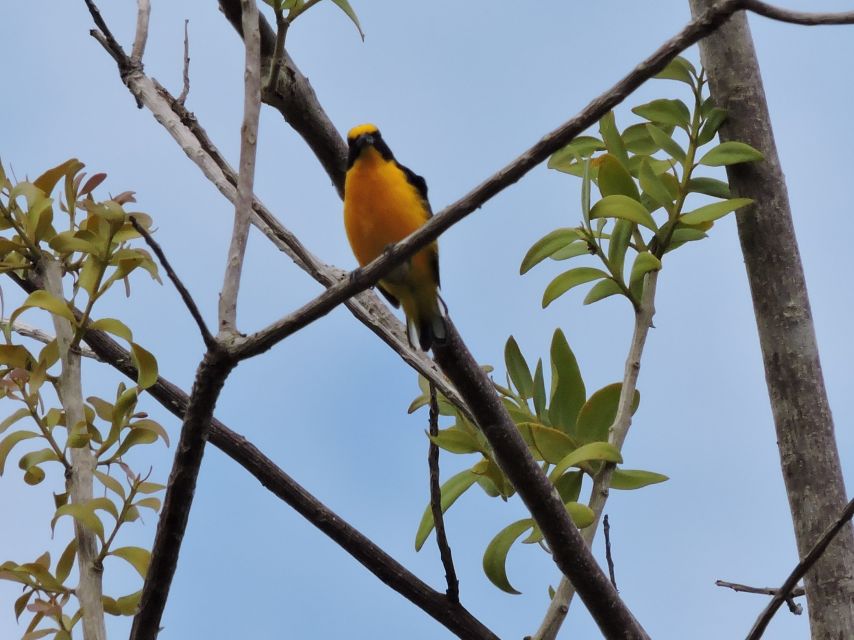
0, 159, 168, 639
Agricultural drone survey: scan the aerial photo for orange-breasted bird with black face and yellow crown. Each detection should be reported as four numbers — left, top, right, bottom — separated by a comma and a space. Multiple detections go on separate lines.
344, 124, 448, 352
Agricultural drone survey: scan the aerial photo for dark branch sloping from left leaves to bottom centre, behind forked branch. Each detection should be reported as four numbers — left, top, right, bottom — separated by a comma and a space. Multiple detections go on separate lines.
7, 274, 498, 640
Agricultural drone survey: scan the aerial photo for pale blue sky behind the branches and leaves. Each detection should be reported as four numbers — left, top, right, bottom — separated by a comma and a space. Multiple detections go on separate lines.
0, 0, 854, 640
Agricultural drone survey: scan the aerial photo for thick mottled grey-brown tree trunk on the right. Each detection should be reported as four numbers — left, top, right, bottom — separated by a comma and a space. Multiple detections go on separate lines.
690, 0, 854, 640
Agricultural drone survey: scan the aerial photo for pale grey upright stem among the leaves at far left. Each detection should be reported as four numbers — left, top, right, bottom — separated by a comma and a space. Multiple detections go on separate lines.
39, 255, 107, 640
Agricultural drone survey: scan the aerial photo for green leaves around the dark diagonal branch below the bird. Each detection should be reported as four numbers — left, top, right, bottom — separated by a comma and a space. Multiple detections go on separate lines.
409, 329, 667, 593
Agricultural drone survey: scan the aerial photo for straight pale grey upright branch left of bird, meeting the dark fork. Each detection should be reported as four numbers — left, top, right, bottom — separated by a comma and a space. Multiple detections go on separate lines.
219, 0, 261, 335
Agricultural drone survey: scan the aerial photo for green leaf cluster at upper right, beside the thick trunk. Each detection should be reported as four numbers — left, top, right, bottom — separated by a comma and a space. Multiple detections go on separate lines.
520, 57, 762, 309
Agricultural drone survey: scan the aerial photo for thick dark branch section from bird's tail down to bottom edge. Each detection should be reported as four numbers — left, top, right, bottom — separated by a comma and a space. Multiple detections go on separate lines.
433, 320, 648, 640
